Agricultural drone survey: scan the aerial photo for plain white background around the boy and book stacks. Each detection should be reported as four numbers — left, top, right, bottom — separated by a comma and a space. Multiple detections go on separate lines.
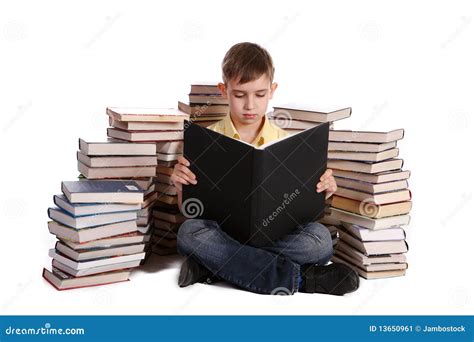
0, 0, 474, 314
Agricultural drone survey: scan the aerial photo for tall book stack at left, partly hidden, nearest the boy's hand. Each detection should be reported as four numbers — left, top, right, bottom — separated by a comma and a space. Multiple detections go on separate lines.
107, 108, 189, 254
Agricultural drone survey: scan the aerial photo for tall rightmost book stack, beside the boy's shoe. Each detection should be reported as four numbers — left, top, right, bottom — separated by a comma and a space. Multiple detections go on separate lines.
323, 129, 412, 279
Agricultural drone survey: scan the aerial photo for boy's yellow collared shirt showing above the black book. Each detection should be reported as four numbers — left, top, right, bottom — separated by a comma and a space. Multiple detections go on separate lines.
207, 113, 290, 147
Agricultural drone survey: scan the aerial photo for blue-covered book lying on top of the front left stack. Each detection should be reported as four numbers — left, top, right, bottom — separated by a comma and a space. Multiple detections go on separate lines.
61, 180, 144, 203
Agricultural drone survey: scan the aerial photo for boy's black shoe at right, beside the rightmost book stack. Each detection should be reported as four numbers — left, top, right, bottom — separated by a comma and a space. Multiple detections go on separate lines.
300, 262, 359, 296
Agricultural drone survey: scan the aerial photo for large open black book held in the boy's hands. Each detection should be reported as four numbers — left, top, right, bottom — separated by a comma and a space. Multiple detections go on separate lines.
182, 122, 329, 247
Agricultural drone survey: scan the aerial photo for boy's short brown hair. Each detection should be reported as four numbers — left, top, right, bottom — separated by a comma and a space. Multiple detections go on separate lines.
222, 42, 275, 84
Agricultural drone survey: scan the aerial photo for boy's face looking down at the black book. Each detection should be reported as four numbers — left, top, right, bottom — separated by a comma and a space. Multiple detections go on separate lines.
219, 74, 278, 125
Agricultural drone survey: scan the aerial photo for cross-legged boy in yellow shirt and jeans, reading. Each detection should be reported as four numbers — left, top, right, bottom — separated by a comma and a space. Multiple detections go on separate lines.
171, 43, 359, 295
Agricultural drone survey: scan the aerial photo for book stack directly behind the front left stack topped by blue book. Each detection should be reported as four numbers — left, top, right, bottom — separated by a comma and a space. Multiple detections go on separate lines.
77, 138, 158, 262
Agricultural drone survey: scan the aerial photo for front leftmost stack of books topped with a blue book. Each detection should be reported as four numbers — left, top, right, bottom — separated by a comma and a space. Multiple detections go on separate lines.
43, 180, 145, 290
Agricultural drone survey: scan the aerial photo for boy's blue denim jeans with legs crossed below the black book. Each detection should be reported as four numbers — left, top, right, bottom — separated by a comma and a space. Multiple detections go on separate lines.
178, 219, 333, 294
